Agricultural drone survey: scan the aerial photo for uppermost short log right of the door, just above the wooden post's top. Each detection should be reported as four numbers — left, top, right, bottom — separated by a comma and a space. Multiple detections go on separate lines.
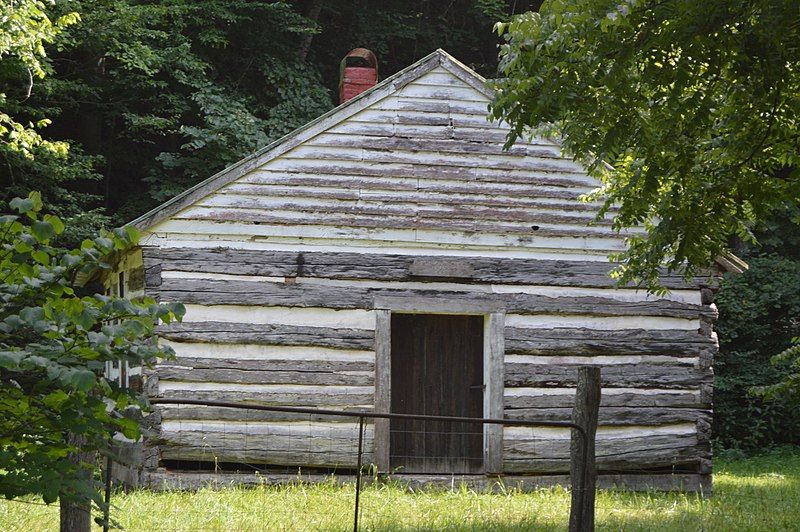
505, 327, 717, 357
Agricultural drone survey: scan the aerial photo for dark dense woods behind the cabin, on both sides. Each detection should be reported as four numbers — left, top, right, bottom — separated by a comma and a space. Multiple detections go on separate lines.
0, 0, 800, 451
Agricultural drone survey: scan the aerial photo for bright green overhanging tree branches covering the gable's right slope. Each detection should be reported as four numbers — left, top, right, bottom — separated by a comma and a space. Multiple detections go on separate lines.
492, 0, 800, 290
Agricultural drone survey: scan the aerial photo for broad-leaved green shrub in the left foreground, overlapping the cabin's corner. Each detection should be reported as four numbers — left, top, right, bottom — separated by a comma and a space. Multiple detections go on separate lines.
0, 192, 184, 504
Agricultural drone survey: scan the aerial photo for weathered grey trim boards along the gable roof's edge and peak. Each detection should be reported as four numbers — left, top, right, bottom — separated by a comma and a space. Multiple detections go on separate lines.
128, 48, 494, 230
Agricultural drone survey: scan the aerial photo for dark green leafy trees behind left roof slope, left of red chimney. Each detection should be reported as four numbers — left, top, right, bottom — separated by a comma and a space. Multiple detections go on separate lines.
38, 0, 331, 223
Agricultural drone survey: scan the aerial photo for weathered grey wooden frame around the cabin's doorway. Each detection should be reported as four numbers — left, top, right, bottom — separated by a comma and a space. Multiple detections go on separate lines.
374, 296, 506, 475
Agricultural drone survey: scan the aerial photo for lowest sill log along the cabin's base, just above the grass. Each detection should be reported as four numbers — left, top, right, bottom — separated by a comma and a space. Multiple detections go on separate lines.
142, 467, 711, 495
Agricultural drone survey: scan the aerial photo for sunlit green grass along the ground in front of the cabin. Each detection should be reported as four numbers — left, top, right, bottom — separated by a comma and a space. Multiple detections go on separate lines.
0, 450, 800, 532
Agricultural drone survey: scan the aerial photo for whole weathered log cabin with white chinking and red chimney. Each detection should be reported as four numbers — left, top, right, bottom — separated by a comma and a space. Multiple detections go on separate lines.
112, 50, 745, 490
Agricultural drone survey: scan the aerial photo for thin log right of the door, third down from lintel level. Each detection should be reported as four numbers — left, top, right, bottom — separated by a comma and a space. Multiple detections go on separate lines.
503, 388, 711, 412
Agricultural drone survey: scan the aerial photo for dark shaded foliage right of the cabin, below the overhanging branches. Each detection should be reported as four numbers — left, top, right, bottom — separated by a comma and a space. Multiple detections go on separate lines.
714, 213, 800, 452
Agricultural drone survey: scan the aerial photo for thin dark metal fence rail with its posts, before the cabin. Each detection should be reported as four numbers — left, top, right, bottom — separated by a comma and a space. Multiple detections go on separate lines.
144, 398, 594, 531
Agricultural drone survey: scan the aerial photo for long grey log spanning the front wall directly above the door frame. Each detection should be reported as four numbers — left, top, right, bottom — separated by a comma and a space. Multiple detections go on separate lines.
152, 278, 713, 319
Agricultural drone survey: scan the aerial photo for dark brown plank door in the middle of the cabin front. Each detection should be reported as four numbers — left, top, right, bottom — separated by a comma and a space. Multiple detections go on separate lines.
389, 314, 484, 473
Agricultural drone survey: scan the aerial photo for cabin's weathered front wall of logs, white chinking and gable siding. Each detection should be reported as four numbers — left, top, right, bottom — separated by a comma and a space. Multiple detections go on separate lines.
134, 66, 717, 486
